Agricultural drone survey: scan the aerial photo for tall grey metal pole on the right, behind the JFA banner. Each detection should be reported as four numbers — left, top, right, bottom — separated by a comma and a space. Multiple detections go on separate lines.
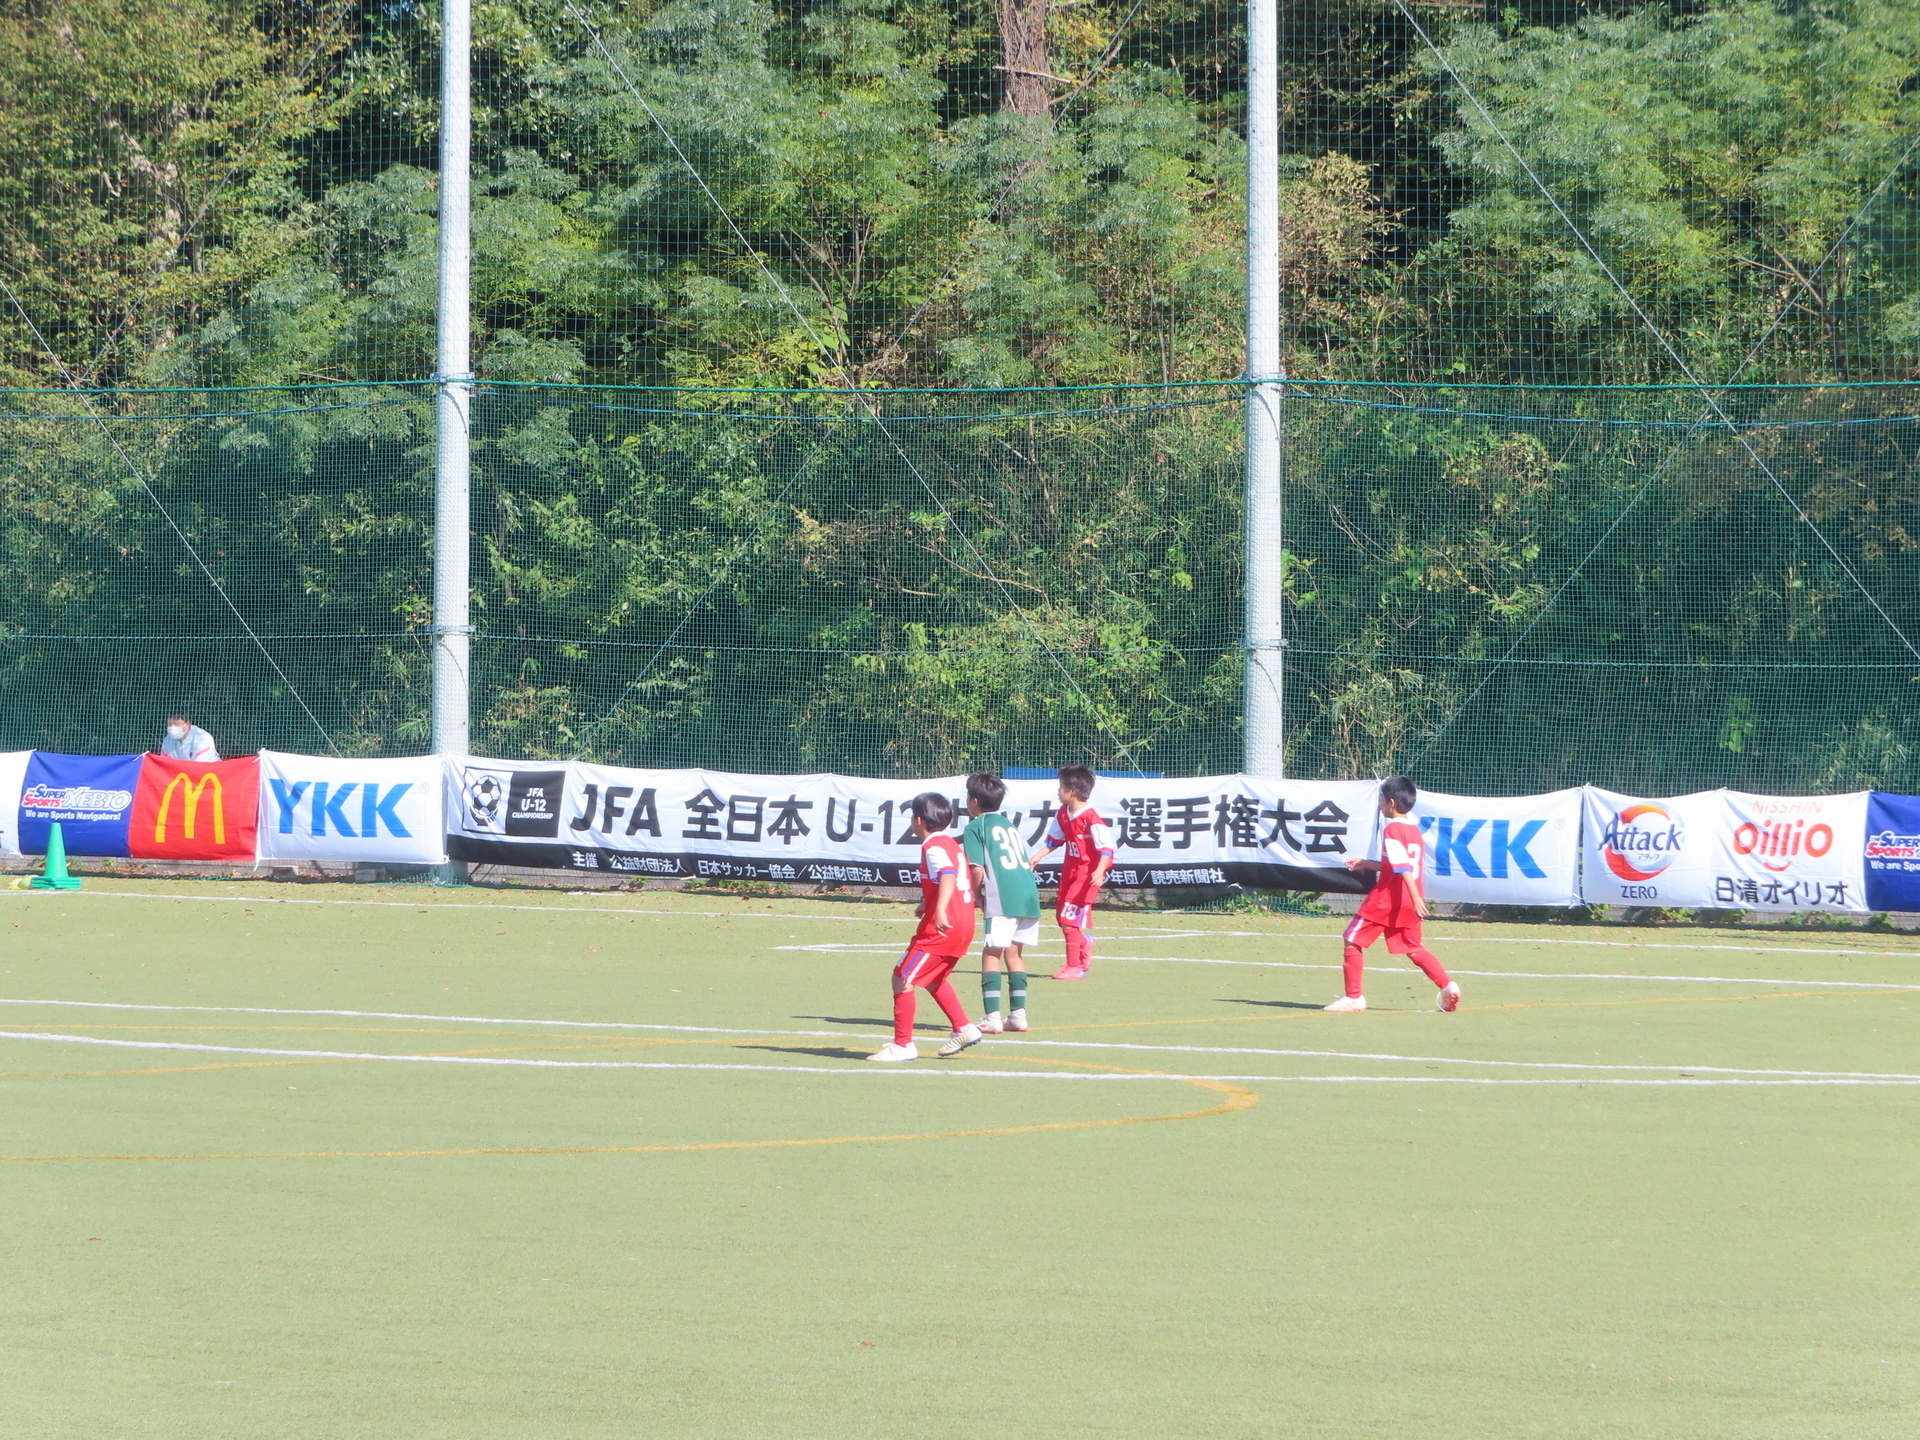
1240, 0, 1286, 776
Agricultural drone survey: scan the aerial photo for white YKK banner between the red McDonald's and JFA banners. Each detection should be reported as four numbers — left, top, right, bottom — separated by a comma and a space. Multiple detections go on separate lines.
259, 751, 447, 864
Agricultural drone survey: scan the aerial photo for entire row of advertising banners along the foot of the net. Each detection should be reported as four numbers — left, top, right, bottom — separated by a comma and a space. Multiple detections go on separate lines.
0, 751, 1920, 914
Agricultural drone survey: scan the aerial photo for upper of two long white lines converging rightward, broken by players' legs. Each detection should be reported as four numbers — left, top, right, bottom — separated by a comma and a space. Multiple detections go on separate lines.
0, 998, 1920, 1085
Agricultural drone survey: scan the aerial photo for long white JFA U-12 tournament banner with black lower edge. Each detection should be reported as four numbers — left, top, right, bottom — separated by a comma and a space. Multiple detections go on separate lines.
445, 758, 1379, 893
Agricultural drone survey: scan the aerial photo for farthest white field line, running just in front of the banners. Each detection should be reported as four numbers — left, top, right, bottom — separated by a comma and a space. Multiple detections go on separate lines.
0, 889, 1920, 963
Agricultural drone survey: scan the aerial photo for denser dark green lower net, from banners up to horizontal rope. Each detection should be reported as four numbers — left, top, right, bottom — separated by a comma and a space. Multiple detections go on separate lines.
0, 384, 1920, 793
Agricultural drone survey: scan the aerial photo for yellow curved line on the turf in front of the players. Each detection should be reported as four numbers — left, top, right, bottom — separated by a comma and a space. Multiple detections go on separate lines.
0, 1041, 1260, 1165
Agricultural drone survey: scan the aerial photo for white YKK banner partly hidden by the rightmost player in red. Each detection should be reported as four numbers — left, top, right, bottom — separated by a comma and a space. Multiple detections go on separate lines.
1413, 789, 1582, 906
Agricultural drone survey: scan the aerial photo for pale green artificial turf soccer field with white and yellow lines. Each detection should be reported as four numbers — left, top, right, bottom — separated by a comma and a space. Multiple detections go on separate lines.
0, 879, 1920, 1440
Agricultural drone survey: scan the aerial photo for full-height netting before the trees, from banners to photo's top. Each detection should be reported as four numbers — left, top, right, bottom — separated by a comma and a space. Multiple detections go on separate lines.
0, 0, 1920, 793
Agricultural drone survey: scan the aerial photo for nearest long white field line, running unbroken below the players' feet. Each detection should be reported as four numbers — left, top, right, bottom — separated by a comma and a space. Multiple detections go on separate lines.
0, 1031, 1920, 1087
